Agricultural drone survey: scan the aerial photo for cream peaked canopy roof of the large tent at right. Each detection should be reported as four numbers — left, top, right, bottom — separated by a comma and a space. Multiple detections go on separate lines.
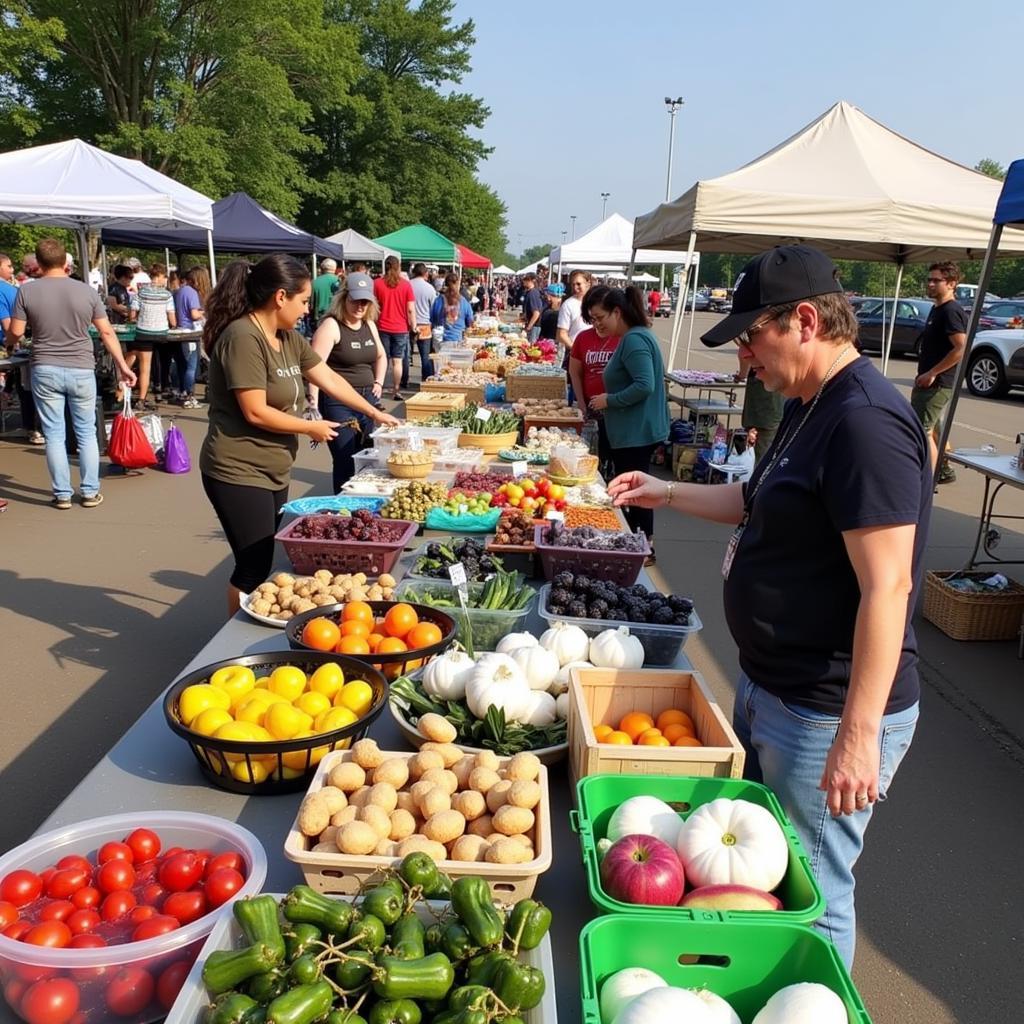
633, 102, 1024, 262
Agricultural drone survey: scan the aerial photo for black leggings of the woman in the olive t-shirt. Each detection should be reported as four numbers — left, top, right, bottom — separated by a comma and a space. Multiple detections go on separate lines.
203, 473, 288, 594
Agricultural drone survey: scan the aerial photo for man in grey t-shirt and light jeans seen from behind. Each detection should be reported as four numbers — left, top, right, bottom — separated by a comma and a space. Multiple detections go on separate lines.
8, 239, 135, 511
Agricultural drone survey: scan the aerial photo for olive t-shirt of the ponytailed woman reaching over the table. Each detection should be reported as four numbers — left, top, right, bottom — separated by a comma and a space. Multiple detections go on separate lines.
199, 316, 322, 490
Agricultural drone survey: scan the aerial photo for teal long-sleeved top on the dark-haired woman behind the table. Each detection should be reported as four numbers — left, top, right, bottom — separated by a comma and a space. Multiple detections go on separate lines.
604, 327, 669, 447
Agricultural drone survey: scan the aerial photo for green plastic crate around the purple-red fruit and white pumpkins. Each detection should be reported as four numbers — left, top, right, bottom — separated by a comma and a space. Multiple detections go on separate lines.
569, 775, 825, 925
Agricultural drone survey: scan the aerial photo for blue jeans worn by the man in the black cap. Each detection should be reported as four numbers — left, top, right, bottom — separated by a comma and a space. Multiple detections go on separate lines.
732, 675, 918, 968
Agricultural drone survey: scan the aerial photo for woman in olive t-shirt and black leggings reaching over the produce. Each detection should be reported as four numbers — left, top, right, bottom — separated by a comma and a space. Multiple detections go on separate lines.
200, 253, 398, 614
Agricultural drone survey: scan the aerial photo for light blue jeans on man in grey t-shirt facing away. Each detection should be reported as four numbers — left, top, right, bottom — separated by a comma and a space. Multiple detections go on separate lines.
32, 367, 99, 499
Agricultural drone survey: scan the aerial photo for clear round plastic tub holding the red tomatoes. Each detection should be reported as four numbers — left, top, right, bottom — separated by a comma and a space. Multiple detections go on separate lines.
0, 811, 266, 1024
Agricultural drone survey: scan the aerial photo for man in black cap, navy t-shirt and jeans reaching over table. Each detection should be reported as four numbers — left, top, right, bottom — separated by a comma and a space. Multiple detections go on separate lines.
608, 246, 932, 965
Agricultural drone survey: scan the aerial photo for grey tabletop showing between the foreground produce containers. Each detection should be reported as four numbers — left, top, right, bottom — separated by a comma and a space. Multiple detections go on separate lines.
40, 538, 692, 1024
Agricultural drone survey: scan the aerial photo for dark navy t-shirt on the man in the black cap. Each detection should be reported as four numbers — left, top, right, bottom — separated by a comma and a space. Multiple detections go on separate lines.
725, 357, 932, 715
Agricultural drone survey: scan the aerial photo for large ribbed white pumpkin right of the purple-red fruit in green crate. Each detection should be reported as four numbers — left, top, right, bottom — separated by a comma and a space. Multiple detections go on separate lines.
676, 797, 790, 892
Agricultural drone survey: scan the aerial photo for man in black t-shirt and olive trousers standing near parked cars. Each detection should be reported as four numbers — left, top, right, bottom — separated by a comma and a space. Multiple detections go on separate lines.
910, 262, 967, 483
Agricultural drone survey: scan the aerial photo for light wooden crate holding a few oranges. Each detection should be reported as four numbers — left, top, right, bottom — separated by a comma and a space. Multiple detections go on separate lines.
568, 669, 745, 793
